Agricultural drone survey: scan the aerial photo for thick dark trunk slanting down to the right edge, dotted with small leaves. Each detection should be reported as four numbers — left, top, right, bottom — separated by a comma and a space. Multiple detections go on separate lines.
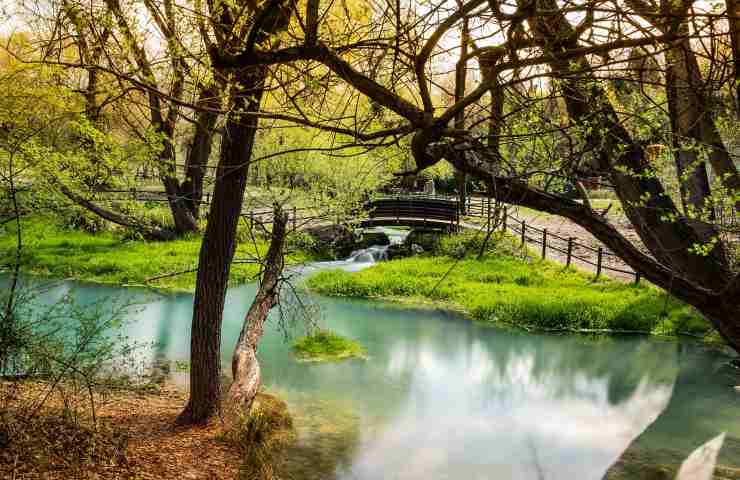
528, 0, 730, 291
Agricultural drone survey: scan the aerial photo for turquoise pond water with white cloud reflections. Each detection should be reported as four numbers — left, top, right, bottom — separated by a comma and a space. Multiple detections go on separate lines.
7, 276, 740, 480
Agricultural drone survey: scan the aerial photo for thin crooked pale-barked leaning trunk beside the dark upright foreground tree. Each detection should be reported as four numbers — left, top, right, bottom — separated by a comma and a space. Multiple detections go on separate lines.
224, 205, 288, 429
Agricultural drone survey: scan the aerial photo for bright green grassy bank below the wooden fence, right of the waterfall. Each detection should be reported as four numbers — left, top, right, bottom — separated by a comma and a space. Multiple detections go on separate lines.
308, 232, 712, 336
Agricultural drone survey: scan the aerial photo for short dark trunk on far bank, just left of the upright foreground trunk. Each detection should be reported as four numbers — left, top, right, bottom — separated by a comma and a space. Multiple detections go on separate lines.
181, 85, 221, 219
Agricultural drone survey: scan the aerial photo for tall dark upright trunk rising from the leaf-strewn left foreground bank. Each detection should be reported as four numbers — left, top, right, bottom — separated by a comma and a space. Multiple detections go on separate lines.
178, 67, 267, 424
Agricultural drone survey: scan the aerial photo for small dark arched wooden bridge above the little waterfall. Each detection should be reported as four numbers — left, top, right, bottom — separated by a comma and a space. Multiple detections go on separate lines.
360, 196, 460, 232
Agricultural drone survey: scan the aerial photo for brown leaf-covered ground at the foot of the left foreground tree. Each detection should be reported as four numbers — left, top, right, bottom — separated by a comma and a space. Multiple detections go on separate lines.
0, 385, 242, 480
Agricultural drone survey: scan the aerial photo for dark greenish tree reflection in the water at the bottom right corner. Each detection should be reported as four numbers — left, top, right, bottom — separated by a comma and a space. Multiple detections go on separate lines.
605, 344, 740, 480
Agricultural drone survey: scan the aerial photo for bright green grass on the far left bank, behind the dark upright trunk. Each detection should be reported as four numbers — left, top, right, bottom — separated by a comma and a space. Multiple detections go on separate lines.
0, 216, 316, 291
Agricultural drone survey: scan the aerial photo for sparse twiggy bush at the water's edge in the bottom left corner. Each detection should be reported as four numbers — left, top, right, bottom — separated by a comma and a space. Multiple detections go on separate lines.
0, 288, 143, 473
